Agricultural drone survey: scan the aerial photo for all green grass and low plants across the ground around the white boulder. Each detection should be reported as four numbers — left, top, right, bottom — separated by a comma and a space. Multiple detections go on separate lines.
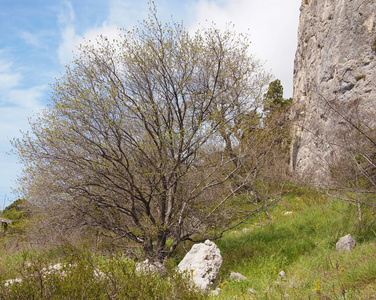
0, 190, 376, 299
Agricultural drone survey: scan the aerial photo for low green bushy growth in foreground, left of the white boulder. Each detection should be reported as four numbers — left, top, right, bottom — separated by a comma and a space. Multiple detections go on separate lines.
0, 251, 204, 299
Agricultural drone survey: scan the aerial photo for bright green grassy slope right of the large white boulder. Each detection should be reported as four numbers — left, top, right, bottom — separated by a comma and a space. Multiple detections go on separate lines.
212, 195, 376, 299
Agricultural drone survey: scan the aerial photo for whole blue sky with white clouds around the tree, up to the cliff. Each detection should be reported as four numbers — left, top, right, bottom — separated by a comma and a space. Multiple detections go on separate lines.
0, 0, 301, 207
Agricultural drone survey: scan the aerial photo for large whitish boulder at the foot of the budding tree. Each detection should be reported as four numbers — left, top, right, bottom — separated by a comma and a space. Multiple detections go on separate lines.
178, 240, 222, 290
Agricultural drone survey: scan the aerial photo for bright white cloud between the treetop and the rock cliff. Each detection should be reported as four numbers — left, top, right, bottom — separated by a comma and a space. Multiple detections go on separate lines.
190, 0, 300, 97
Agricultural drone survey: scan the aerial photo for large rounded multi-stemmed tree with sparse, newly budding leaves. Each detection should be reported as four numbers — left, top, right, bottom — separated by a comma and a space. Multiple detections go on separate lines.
14, 7, 269, 261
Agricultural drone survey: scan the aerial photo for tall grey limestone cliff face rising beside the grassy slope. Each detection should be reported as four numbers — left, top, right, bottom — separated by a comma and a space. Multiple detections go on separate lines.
291, 0, 376, 182
